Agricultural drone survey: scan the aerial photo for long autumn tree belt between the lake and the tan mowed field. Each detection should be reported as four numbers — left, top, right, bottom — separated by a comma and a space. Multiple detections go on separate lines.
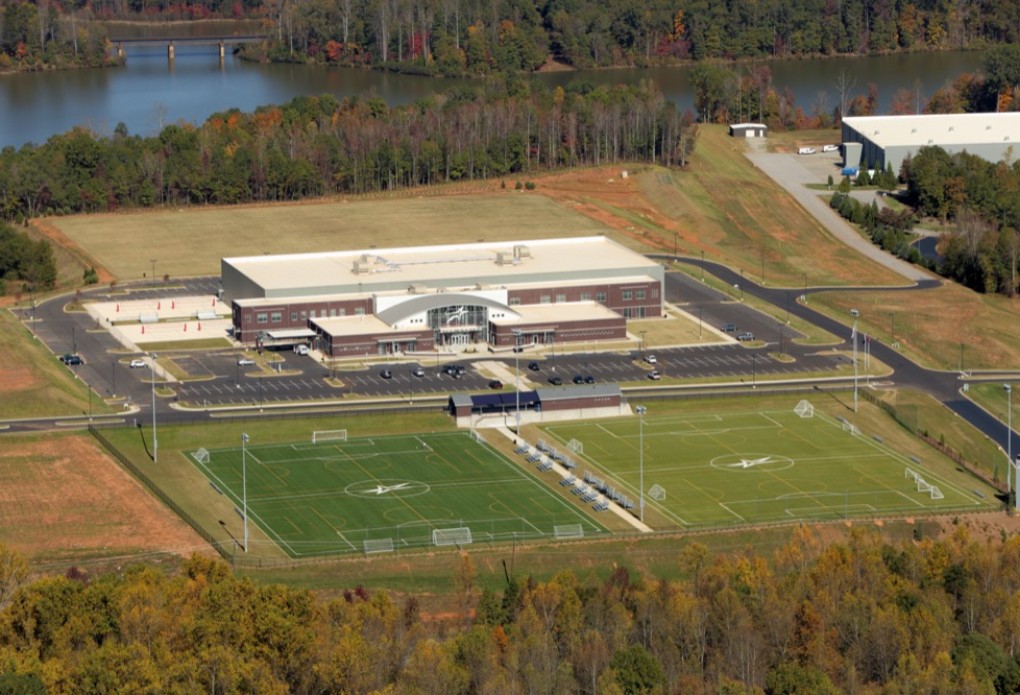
0, 80, 697, 219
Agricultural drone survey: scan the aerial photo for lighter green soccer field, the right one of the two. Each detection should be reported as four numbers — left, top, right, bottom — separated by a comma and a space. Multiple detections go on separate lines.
544, 409, 995, 528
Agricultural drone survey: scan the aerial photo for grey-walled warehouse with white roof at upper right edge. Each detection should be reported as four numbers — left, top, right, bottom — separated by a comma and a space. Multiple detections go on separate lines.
843, 112, 1020, 173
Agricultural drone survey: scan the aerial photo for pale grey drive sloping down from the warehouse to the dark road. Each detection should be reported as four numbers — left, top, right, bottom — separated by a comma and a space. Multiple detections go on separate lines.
747, 152, 934, 283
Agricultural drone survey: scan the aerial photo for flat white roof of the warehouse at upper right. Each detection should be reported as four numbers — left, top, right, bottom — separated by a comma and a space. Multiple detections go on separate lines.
843, 111, 1020, 147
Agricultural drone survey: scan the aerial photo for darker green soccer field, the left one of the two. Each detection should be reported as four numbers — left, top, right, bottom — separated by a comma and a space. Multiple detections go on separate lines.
188, 432, 605, 557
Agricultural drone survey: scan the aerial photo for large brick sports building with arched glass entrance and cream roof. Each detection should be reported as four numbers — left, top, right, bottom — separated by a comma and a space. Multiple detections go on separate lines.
220, 236, 664, 357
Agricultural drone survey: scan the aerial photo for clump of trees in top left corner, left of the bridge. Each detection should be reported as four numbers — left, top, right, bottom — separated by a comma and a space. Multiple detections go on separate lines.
0, 0, 115, 71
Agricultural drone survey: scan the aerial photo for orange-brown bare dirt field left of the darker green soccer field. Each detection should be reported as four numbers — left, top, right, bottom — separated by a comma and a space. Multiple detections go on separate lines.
0, 434, 208, 561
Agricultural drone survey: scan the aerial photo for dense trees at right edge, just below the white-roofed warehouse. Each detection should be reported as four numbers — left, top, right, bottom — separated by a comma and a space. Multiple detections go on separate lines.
901, 147, 1020, 296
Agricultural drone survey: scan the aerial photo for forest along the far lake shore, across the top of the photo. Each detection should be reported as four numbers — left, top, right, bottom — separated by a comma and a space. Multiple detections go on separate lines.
0, 0, 1020, 76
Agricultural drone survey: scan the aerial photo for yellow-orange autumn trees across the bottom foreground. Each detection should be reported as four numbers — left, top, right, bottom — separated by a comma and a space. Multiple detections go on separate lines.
7, 528, 1020, 695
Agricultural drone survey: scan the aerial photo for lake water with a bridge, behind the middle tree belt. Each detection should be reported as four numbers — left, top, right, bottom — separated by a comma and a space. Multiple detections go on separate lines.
0, 46, 983, 147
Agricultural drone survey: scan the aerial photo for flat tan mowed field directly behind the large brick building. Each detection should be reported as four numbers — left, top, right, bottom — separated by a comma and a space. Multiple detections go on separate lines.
47, 189, 608, 281
